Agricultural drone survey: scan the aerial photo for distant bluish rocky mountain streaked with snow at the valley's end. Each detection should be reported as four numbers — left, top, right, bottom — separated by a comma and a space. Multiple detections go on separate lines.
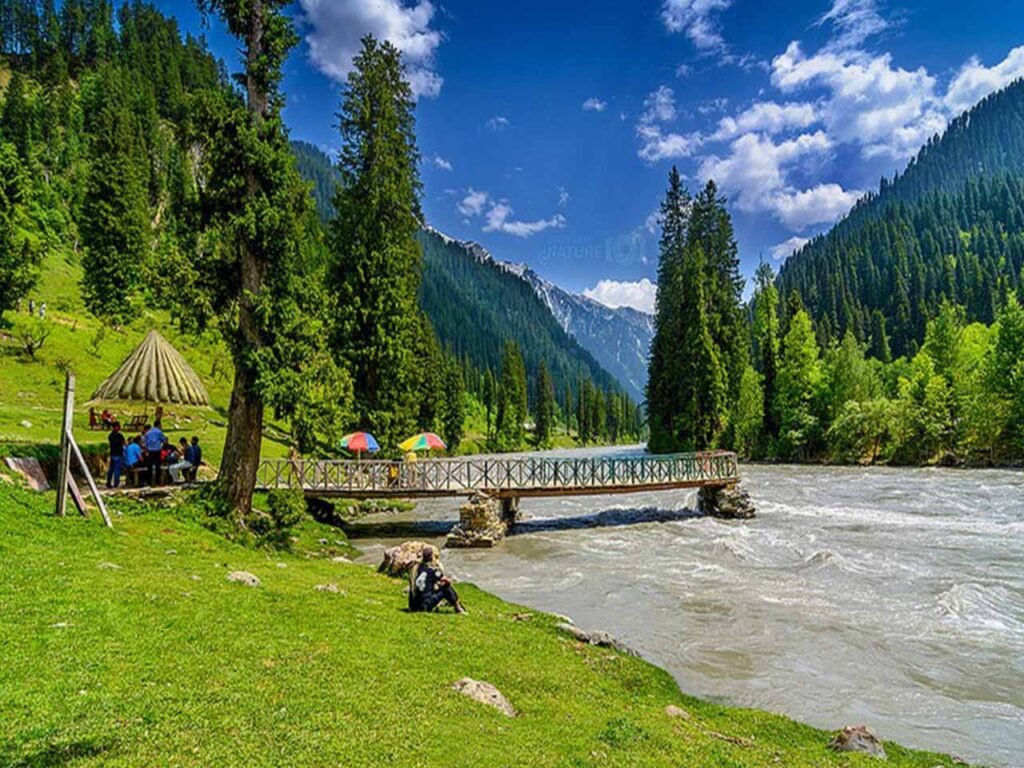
521, 267, 654, 402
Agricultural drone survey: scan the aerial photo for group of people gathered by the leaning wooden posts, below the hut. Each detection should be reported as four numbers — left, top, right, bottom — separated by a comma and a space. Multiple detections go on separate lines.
106, 420, 203, 488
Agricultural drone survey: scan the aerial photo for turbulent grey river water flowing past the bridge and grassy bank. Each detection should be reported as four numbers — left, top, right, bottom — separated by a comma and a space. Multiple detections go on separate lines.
356, 450, 1024, 768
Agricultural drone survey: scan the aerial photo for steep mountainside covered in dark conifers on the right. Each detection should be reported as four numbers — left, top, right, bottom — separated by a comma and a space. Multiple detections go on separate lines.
778, 81, 1024, 355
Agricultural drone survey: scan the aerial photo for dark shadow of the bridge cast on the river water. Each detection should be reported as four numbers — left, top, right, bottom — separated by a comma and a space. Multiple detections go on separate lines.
341, 507, 702, 539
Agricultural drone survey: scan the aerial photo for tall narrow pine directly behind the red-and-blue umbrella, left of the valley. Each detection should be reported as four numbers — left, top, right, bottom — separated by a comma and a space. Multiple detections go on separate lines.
330, 36, 422, 443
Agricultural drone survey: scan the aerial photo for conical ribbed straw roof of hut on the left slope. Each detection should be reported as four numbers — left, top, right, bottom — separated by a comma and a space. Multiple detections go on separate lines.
92, 331, 210, 406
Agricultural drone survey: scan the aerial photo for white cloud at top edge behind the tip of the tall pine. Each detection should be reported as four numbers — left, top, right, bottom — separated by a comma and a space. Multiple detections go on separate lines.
299, 0, 444, 97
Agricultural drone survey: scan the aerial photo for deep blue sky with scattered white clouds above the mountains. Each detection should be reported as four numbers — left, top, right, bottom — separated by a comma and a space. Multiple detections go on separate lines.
158, 0, 1024, 310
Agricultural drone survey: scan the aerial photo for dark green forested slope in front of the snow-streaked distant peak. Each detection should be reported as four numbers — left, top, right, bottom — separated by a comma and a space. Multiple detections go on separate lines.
420, 228, 625, 402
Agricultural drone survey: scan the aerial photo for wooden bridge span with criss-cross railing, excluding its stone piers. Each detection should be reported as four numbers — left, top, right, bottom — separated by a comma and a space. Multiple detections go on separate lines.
256, 452, 739, 499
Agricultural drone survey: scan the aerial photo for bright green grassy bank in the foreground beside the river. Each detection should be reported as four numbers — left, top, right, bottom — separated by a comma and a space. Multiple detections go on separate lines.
0, 481, 966, 768
